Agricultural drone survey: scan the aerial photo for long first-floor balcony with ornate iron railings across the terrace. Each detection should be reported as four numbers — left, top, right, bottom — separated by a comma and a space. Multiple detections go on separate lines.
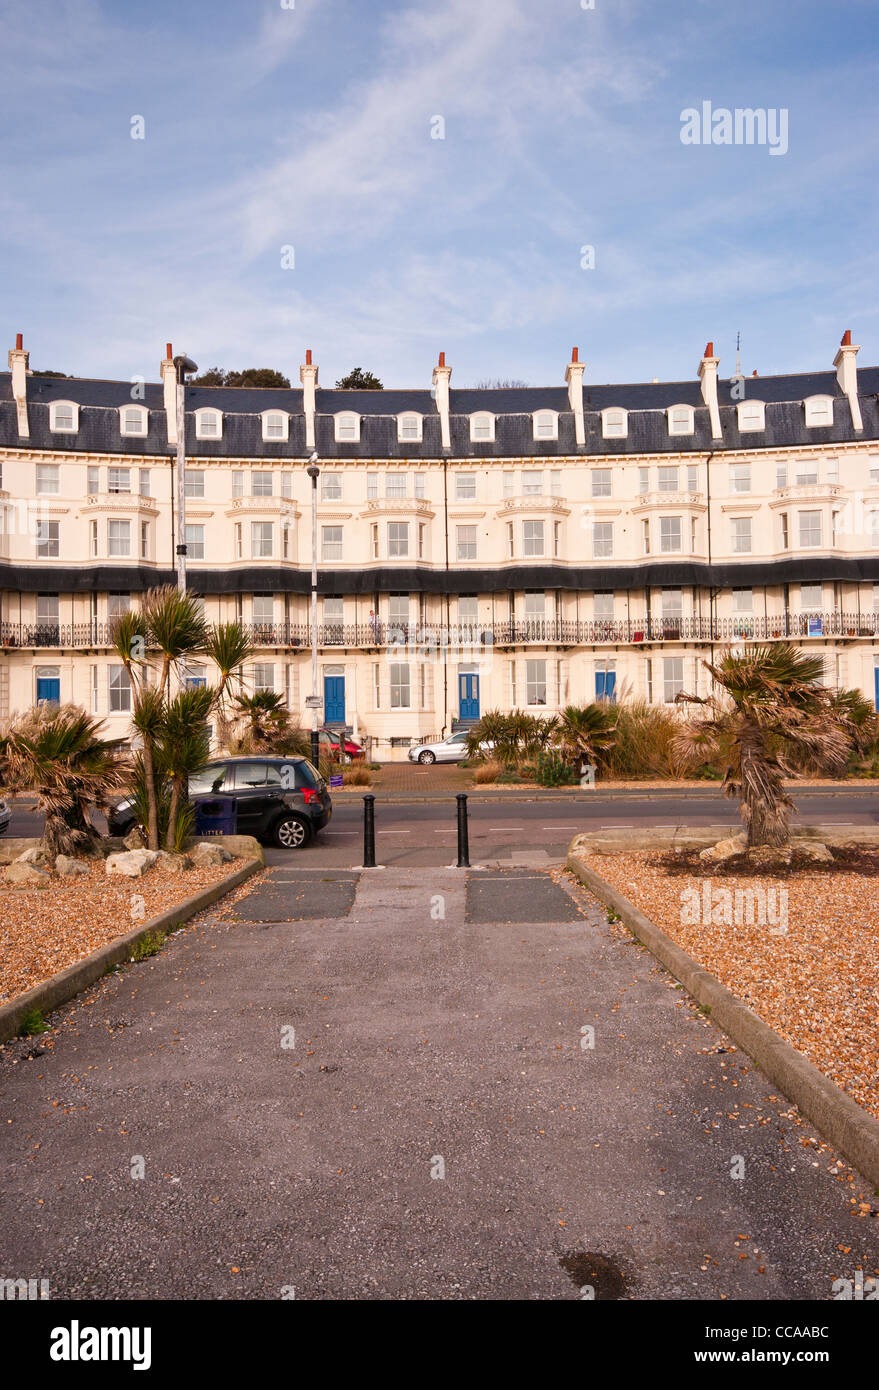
0, 610, 879, 651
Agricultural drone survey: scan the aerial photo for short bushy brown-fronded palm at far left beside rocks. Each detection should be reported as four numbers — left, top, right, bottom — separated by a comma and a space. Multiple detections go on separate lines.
0, 705, 131, 858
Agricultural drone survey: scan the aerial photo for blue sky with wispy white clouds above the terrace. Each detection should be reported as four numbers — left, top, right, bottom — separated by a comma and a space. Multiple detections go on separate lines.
0, 0, 879, 386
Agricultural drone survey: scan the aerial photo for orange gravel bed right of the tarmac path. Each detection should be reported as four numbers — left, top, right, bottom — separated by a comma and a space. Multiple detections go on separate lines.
581, 849, 879, 1116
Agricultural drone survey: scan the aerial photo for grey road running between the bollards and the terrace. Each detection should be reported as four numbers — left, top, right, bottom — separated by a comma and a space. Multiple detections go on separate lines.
10, 790, 879, 869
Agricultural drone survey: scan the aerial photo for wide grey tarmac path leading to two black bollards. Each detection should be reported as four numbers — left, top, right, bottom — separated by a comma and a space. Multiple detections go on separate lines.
0, 867, 879, 1300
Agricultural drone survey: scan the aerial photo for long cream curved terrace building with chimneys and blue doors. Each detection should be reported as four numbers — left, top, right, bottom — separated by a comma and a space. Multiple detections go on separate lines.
0, 332, 879, 758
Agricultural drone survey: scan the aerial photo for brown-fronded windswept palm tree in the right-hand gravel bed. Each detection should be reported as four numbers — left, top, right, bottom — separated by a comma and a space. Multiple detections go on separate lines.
672, 642, 854, 847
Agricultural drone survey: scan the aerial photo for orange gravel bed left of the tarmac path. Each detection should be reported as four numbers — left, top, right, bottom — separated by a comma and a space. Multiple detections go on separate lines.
0, 859, 250, 1004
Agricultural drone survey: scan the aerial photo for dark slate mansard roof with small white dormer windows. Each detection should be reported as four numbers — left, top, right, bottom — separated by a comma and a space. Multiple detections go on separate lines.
0, 367, 879, 461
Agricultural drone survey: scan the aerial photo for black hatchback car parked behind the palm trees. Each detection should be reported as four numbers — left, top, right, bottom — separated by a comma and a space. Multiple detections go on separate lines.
107, 756, 332, 849
